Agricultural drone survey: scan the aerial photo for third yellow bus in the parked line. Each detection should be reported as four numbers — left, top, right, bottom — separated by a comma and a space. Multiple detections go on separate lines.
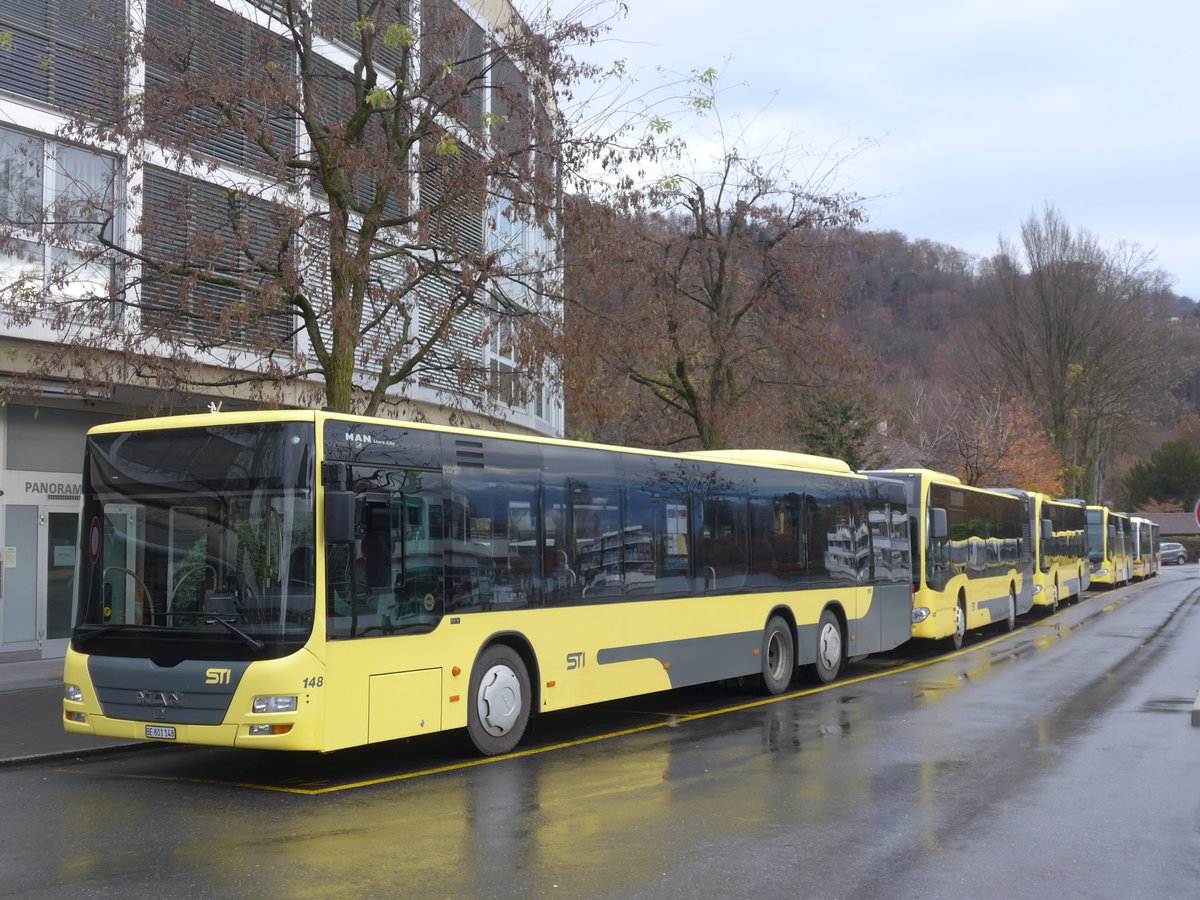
1004, 488, 1091, 610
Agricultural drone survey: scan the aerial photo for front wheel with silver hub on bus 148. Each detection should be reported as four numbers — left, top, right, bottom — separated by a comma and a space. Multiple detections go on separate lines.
467, 643, 532, 756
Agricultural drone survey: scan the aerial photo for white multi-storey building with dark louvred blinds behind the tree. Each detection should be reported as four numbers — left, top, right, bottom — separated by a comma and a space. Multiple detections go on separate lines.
0, 0, 563, 662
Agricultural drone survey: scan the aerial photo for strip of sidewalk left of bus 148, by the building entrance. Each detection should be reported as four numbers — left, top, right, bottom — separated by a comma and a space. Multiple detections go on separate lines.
0, 659, 141, 766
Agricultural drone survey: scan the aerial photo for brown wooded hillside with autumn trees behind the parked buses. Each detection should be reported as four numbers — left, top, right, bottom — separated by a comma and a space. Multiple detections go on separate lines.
564, 191, 1200, 504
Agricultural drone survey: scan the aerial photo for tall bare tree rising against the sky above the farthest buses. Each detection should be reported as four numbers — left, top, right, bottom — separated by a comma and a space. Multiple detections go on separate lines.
978, 206, 1172, 500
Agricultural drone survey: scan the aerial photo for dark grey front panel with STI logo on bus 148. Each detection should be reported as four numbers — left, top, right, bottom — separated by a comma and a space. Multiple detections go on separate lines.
88, 656, 250, 725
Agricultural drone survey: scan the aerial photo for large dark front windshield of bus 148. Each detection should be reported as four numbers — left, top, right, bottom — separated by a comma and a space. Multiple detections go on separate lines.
73, 422, 314, 665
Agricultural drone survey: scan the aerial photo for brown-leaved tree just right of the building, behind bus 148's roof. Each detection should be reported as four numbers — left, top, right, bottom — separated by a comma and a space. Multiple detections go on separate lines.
565, 142, 859, 449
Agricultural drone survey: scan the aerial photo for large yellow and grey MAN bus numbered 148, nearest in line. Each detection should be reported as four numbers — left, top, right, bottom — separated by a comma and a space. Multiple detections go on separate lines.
64, 412, 911, 754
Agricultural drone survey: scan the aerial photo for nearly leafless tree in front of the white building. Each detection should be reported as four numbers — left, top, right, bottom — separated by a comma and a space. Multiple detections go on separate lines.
0, 0, 647, 413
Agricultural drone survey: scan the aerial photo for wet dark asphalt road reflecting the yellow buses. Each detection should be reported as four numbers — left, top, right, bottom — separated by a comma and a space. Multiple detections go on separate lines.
0, 566, 1200, 900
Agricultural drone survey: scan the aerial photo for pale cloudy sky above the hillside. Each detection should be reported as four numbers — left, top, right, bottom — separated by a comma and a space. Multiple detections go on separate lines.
554, 0, 1200, 300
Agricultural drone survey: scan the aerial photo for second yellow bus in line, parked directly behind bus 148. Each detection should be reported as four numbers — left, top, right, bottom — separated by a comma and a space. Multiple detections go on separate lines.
868, 469, 1033, 649
